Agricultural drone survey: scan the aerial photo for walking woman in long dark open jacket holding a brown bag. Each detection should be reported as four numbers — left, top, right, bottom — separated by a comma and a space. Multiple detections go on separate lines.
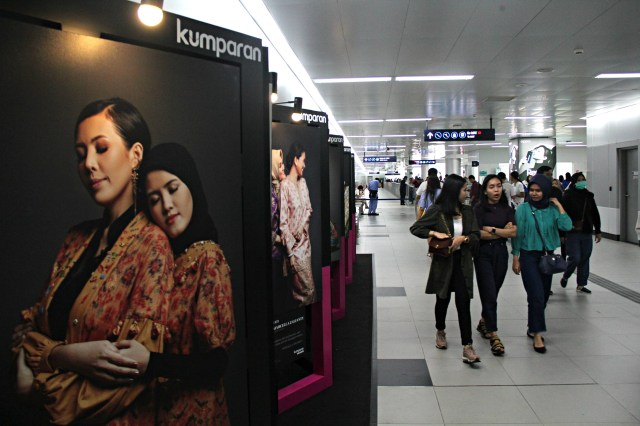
411, 175, 480, 364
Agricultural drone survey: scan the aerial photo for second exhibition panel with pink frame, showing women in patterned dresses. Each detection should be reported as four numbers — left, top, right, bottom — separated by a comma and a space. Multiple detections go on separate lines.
271, 105, 333, 412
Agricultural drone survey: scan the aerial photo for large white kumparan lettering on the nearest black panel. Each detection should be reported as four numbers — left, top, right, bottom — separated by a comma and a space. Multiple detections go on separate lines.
176, 18, 262, 62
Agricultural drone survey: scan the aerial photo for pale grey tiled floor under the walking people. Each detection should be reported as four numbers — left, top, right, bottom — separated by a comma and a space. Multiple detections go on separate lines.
357, 190, 640, 425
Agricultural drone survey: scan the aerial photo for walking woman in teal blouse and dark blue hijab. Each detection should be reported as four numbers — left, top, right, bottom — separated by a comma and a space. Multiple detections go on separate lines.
511, 174, 571, 353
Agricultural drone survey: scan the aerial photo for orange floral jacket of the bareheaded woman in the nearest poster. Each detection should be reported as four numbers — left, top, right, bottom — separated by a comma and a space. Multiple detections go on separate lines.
23, 213, 173, 425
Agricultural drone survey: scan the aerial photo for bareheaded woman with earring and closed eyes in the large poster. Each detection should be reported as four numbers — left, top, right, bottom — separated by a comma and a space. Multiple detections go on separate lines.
13, 98, 173, 424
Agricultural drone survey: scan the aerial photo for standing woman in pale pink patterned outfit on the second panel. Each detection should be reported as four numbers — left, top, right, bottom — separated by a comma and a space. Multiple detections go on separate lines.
280, 143, 316, 306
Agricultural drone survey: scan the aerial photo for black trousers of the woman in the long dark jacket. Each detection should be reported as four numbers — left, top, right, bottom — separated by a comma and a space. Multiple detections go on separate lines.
435, 250, 473, 345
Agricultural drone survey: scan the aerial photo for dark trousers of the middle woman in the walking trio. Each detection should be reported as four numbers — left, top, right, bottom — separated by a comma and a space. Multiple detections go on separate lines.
474, 240, 509, 331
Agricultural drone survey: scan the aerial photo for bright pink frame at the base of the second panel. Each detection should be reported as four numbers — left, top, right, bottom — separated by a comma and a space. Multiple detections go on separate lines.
278, 266, 333, 413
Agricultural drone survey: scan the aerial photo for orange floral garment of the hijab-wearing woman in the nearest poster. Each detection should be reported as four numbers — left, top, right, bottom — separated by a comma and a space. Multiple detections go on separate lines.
158, 241, 236, 426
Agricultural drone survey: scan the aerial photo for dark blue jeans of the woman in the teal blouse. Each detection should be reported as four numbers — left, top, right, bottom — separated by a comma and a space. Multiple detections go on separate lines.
520, 250, 553, 333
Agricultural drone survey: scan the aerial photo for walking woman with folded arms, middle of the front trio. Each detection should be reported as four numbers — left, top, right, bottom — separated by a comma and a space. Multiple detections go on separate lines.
473, 175, 517, 356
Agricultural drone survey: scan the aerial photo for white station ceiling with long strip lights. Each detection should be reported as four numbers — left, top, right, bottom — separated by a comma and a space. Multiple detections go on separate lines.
264, 0, 640, 165
